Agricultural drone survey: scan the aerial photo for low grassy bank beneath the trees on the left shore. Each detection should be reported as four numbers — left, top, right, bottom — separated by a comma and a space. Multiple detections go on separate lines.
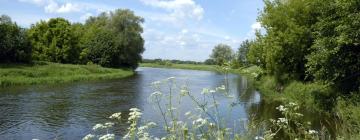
0, 62, 133, 87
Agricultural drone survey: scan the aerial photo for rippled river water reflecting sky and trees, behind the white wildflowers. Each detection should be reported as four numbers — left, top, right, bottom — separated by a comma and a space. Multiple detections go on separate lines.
0, 68, 334, 140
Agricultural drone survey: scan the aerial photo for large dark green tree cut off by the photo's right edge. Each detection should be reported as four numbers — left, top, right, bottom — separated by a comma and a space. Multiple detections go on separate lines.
307, 0, 360, 93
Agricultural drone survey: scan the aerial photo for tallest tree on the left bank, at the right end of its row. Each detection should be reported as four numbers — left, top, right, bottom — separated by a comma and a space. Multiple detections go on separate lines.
83, 9, 145, 69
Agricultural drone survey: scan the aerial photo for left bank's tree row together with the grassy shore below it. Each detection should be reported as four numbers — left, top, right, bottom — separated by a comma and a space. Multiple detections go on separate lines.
0, 9, 144, 86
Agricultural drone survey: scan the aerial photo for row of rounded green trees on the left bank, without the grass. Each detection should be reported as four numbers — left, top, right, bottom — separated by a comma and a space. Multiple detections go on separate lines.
0, 9, 144, 69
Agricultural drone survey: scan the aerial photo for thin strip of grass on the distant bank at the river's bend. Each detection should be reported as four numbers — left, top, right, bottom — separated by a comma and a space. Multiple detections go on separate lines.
140, 63, 218, 71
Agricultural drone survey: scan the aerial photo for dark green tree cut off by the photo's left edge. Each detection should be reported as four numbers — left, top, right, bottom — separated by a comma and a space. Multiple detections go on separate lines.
0, 15, 31, 63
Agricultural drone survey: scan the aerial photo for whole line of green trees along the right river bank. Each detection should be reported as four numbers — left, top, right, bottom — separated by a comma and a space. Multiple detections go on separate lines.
207, 0, 360, 93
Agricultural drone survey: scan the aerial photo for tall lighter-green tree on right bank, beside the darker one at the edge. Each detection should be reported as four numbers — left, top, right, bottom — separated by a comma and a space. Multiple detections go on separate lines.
259, 0, 318, 81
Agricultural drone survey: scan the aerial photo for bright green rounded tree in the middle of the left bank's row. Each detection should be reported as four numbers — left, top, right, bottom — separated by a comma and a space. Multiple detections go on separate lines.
28, 18, 80, 63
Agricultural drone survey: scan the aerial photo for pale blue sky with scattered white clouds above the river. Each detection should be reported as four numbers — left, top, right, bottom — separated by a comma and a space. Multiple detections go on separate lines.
0, 0, 264, 61
